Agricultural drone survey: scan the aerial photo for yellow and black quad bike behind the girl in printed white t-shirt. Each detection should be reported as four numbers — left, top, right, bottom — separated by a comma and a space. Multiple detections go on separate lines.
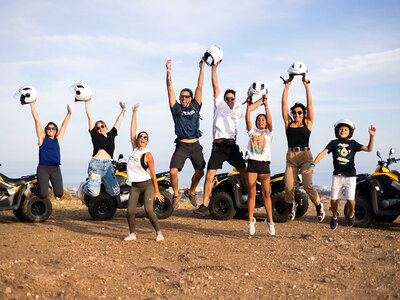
208, 170, 308, 222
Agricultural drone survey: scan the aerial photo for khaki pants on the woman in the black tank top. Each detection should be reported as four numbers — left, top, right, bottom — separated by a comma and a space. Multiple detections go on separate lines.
285, 150, 321, 206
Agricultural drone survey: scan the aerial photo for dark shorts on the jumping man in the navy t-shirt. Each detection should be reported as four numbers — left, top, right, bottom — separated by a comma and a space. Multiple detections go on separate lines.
169, 141, 206, 171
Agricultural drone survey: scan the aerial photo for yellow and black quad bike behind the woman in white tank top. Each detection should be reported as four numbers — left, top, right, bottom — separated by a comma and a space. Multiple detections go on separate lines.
83, 154, 173, 221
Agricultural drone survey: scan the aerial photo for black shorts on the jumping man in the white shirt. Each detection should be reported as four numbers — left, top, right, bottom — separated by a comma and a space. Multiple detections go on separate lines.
207, 141, 246, 170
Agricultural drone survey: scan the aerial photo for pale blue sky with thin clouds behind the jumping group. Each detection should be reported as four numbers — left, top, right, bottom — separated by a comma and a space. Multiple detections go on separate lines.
0, 0, 400, 186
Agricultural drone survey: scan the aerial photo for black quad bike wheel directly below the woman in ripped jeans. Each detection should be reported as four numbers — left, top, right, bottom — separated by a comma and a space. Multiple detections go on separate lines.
88, 193, 117, 221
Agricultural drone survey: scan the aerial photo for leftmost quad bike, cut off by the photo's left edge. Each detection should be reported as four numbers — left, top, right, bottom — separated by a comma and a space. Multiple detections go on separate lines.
0, 165, 53, 222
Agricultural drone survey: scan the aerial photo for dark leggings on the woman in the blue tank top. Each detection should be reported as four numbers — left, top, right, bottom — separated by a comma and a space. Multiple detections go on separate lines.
33, 165, 64, 198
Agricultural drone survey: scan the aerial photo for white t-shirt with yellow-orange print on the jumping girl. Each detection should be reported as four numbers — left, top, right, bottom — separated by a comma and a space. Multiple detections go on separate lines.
247, 128, 272, 161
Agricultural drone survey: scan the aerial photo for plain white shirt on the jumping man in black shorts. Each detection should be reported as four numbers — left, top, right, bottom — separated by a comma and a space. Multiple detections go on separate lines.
213, 93, 246, 140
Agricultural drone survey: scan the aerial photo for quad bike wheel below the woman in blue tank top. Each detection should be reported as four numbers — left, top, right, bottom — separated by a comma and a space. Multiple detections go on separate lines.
21, 196, 53, 222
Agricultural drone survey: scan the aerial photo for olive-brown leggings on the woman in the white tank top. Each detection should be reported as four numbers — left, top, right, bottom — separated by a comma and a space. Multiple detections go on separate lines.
128, 179, 160, 233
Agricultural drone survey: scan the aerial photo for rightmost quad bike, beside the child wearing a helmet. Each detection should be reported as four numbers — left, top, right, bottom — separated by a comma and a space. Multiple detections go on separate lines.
344, 148, 400, 227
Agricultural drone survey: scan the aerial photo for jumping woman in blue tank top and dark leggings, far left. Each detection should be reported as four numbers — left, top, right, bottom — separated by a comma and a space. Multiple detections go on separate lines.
30, 101, 71, 199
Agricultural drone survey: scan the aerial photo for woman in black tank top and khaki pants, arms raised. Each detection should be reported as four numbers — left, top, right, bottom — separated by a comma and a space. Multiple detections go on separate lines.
282, 78, 325, 222
